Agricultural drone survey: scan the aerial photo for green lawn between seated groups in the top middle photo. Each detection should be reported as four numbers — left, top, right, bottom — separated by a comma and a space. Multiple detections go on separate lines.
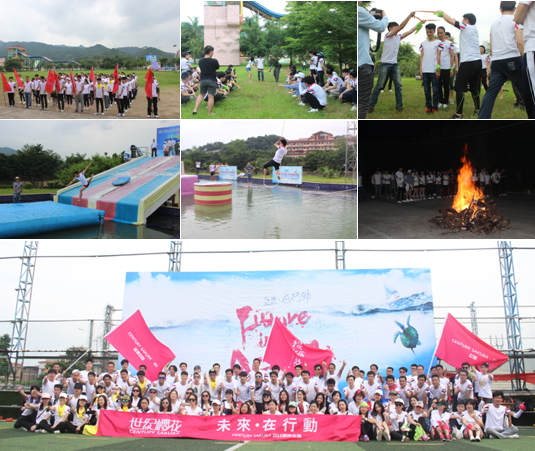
181, 66, 357, 119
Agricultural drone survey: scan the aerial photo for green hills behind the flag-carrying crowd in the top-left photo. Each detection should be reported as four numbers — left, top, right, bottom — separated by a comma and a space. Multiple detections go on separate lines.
0, 41, 175, 61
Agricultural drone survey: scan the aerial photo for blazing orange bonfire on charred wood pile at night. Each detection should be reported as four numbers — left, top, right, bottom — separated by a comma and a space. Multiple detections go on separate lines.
429, 146, 511, 235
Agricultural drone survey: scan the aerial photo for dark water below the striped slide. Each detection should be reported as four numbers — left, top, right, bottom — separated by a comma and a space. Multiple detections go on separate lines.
23, 215, 180, 240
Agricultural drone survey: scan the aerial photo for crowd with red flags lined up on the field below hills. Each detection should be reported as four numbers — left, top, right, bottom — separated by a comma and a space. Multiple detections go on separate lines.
4, 72, 160, 118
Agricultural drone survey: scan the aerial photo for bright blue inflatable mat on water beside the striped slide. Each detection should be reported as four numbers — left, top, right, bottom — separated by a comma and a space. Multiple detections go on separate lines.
0, 201, 104, 238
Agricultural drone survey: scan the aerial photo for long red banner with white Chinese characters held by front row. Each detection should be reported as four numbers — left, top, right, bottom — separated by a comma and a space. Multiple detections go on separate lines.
97, 410, 360, 442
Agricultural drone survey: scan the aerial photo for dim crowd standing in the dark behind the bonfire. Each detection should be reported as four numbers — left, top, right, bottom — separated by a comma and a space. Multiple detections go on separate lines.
358, 168, 507, 204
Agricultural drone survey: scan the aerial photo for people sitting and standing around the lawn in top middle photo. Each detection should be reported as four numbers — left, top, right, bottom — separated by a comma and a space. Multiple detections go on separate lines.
180, 46, 357, 115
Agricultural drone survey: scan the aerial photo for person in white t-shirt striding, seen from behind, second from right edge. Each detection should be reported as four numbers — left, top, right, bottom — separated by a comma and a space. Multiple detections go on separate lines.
478, 2, 524, 119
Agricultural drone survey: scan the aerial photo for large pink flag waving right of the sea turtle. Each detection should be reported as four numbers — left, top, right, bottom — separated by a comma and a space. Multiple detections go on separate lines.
435, 313, 509, 371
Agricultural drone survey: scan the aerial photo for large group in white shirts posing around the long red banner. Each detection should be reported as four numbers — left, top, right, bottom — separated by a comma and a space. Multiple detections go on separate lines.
11, 358, 526, 442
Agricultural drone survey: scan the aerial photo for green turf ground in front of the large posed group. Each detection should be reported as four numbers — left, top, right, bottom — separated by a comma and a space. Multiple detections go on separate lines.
0, 422, 535, 451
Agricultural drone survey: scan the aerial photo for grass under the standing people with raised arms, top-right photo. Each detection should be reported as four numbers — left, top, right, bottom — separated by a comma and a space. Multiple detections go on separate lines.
367, 78, 528, 119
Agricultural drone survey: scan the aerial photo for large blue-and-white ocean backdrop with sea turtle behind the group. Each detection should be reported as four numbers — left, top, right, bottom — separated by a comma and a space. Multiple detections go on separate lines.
123, 268, 436, 391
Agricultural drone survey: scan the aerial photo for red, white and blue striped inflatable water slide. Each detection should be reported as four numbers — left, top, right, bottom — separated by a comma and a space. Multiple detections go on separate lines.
55, 156, 180, 225
